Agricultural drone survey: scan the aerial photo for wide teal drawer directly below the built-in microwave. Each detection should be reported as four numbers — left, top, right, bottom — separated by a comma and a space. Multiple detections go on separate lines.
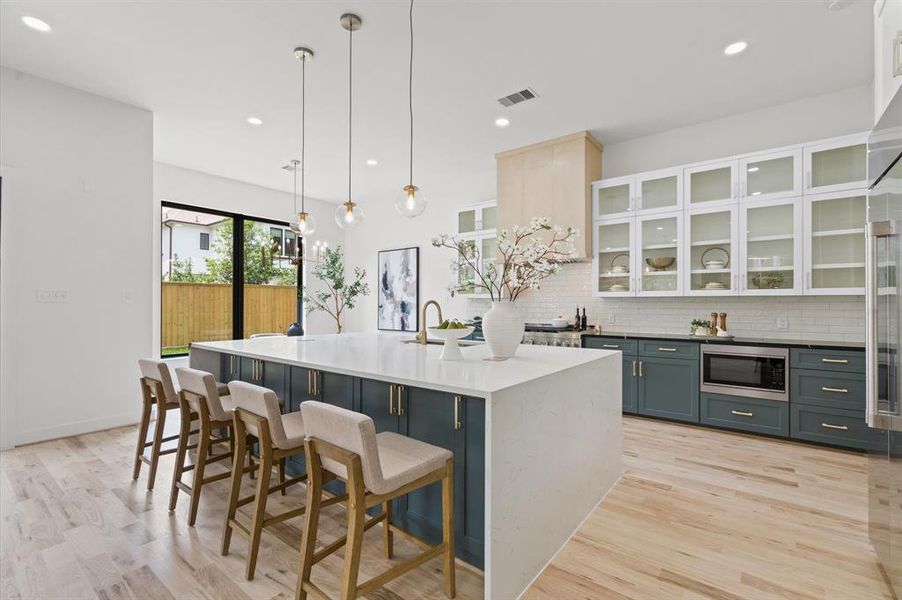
700, 394, 789, 436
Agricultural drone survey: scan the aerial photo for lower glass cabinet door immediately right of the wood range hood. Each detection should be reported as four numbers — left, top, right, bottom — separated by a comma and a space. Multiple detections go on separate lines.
595, 219, 634, 296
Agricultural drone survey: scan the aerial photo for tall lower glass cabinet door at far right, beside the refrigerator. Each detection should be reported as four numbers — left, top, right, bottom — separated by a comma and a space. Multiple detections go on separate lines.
805, 191, 867, 294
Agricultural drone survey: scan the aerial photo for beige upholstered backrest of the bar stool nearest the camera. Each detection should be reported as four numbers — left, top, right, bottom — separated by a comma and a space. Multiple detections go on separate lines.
301, 400, 384, 490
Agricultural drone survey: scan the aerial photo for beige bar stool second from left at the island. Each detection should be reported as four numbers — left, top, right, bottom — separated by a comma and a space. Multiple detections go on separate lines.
169, 367, 256, 527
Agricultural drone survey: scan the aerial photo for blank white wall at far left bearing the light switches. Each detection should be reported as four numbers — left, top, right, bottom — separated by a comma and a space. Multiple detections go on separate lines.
0, 68, 158, 444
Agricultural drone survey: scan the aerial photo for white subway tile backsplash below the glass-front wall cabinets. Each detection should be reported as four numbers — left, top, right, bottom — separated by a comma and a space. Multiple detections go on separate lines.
468, 263, 864, 342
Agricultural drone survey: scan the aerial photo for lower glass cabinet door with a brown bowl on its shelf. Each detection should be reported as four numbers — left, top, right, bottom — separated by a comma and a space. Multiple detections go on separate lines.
636, 213, 682, 296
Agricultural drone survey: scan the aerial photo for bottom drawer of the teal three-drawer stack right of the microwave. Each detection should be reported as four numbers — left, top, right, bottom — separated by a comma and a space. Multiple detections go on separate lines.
789, 404, 868, 450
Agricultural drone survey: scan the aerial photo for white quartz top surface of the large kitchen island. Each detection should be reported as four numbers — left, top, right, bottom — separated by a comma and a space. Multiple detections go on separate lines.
191, 333, 620, 397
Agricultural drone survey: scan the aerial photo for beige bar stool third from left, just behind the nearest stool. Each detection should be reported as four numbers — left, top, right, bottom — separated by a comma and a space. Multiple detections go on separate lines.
222, 381, 322, 580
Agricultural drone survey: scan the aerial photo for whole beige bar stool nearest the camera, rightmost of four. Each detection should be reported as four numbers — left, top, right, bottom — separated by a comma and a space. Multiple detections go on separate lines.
295, 401, 455, 600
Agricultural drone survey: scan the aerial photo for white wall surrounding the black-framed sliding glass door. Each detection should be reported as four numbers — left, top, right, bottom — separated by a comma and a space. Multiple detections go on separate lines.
152, 159, 344, 344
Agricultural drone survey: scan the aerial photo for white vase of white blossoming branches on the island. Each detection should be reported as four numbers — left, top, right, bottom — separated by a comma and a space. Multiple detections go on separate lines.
432, 217, 577, 359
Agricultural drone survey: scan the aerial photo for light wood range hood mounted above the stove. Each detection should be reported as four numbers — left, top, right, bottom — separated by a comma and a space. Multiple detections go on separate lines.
495, 131, 603, 261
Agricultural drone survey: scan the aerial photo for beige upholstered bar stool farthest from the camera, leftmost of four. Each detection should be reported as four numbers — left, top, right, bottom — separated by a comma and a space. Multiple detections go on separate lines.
132, 358, 228, 491
